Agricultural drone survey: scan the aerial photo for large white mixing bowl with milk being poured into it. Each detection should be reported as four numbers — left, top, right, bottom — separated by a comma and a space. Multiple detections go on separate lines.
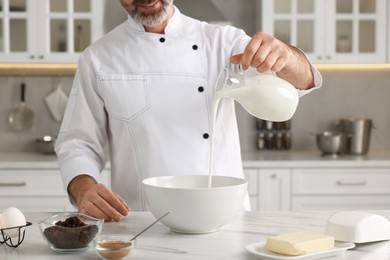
143, 175, 248, 233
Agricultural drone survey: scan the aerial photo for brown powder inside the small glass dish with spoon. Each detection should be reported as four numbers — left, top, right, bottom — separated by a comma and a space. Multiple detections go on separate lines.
96, 241, 132, 260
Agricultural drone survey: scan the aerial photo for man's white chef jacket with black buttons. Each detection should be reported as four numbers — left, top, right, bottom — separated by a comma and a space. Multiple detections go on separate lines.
55, 7, 321, 210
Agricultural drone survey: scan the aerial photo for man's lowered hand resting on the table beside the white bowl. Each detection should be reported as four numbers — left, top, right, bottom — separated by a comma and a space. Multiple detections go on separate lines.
68, 175, 130, 221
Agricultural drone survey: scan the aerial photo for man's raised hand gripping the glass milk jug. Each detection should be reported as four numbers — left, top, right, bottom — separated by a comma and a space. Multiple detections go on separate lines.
230, 32, 314, 89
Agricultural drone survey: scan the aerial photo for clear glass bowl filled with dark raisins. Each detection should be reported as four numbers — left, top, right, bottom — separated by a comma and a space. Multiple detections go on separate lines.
38, 212, 104, 253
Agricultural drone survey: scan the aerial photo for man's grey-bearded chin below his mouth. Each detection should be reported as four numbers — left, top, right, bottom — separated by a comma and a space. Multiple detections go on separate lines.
129, 0, 173, 26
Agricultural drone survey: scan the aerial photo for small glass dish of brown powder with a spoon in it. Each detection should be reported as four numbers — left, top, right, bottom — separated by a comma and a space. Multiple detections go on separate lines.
93, 234, 135, 260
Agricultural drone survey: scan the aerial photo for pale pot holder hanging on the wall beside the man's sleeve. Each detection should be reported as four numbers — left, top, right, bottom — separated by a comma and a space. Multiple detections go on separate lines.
45, 82, 68, 122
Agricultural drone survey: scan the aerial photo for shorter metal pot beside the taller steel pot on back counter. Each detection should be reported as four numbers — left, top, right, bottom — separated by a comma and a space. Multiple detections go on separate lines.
316, 131, 347, 155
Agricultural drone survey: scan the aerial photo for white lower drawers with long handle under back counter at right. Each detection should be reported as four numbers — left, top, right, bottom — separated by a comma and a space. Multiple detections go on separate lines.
291, 168, 390, 210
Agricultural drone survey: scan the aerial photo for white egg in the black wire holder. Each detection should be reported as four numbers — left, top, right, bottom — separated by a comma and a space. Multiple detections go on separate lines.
0, 207, 26, 237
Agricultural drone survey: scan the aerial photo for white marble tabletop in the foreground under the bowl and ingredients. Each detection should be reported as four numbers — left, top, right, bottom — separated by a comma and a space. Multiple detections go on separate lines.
0, 211, 390, 260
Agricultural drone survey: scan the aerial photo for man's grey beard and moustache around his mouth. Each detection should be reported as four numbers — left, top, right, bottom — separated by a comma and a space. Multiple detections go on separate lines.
121, 0, 173, 26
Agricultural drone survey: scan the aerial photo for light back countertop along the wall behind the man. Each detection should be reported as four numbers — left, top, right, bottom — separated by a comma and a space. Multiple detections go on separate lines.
0, 151, 390, 169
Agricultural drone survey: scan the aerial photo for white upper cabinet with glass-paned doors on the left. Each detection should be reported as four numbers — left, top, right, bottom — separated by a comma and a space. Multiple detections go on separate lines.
0, 0, 103, 63
